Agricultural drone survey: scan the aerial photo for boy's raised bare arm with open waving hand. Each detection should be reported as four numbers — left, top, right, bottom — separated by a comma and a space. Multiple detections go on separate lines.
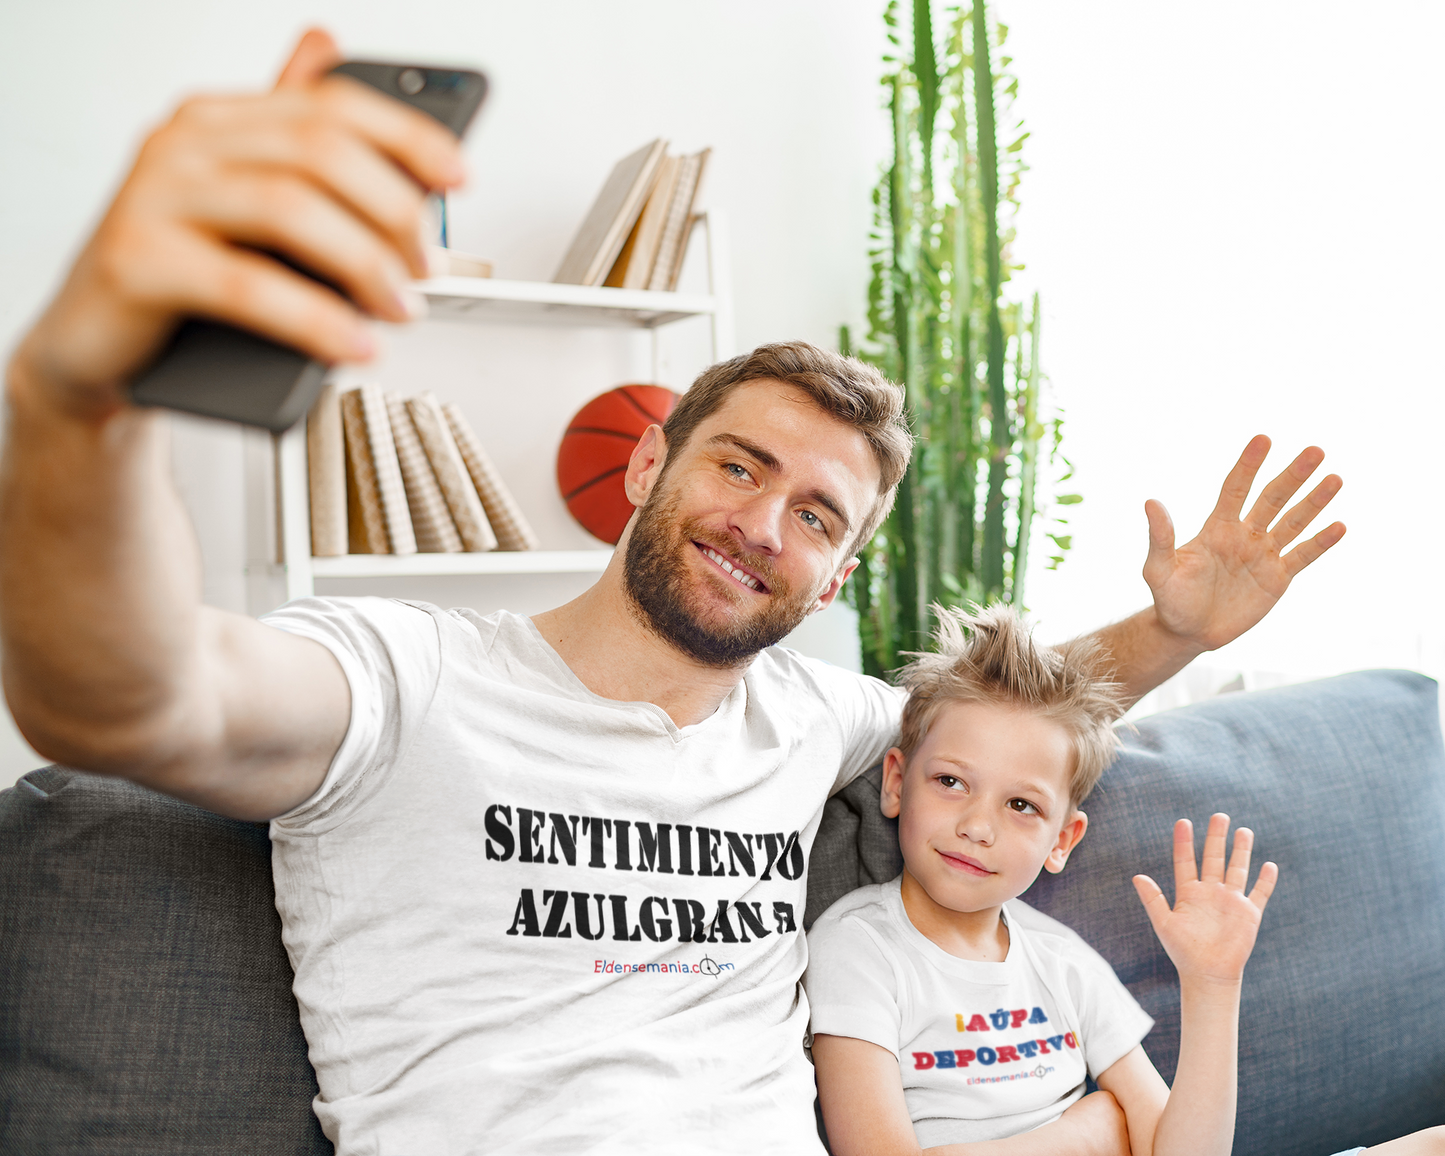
1098, 815, 1279, 1156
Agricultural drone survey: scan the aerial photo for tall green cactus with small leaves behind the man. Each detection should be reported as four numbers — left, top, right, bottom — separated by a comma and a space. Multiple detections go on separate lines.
840, 0, 1079, 675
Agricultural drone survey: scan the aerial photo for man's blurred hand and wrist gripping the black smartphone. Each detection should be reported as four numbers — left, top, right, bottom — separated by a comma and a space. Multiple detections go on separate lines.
10, 30, 464, 420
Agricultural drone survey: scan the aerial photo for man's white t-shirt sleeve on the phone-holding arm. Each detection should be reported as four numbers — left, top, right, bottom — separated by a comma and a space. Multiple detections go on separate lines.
262, 598, 441, 832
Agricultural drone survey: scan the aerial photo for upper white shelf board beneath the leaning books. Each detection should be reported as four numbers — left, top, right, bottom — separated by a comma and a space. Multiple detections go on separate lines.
418, 277, 717, 329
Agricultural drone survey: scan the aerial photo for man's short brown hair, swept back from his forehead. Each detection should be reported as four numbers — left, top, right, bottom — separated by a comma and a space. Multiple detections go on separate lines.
662, 341, 913, 553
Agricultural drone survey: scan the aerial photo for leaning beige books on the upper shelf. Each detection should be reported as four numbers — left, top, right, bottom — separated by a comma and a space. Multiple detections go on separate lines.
552, 140, 711, 290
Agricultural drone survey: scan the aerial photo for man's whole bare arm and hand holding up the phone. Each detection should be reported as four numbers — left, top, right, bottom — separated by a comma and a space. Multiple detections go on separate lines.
0, 32, 462, 819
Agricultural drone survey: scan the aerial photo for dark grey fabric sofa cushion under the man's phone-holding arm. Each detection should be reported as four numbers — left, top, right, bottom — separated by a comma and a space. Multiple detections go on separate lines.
0, 767, 332, 1156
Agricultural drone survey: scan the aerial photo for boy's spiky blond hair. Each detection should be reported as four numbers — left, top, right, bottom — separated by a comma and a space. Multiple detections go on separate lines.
899, 603, 1127, 806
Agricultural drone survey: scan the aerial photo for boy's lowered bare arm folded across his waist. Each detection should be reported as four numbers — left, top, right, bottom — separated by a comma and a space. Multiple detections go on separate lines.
812, 1036, 1127, 1156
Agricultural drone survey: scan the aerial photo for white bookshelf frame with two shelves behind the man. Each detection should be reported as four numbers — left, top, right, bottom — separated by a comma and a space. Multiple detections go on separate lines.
277, 211, 734, 600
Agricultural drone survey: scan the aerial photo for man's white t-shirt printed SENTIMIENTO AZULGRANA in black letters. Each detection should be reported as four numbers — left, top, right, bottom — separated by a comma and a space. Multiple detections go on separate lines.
266, 598, 899, 1156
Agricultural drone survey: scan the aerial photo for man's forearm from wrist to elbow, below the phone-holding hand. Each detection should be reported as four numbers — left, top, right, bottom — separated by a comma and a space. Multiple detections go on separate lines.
0, 347, 201, 772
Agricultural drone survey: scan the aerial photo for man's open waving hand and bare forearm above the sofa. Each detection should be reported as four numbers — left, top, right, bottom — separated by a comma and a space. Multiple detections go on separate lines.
1092, 434, 1345, 699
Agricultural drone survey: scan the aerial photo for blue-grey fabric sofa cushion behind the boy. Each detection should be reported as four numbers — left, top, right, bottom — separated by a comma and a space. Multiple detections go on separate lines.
808, 670, 1445, 1156
